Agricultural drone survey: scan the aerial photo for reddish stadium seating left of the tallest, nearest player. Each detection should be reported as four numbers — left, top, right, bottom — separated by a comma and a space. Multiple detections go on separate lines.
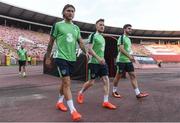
0, 26, 49, 61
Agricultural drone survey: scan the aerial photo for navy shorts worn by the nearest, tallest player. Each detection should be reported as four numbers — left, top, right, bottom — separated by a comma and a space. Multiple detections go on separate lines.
54, 58, 75, 77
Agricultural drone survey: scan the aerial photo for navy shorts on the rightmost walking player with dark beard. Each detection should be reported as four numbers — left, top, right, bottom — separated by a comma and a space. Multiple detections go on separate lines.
116, 62, 134, 74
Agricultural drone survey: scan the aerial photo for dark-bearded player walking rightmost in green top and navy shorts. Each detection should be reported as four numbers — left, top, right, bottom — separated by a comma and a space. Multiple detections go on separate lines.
112, 24, 149, 98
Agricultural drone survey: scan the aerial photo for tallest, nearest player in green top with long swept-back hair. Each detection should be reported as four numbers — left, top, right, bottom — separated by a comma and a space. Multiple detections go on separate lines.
45, 4, 87, 121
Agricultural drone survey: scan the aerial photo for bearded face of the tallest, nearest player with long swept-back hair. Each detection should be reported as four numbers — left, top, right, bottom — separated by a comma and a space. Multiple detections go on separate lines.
64, 7, 75, 20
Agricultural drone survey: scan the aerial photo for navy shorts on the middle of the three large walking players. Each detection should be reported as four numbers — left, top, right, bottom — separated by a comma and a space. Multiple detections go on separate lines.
88, 63, 109, 80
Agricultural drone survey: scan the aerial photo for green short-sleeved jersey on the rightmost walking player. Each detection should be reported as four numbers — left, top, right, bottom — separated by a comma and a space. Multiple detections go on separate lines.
116, 35, 132, 63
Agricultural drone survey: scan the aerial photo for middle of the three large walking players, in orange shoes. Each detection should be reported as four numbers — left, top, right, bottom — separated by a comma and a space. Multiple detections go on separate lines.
77, 19, 116, 109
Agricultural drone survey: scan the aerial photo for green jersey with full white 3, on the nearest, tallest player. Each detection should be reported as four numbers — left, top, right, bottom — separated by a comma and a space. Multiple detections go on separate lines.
51, 21, 81, 61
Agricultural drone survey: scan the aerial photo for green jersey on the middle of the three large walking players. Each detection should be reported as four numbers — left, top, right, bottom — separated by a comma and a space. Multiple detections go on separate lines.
89, 32, 105, 64
